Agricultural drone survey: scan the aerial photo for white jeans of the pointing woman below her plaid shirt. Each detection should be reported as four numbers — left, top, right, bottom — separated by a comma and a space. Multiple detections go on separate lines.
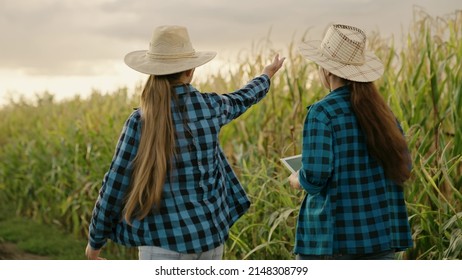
138, 245, 224, 260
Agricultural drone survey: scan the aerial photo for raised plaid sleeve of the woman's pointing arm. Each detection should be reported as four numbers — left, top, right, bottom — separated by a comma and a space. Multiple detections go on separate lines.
215, 74, 271, 125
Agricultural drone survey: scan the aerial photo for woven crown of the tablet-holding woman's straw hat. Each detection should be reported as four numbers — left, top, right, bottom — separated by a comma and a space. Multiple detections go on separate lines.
320, 24, 366, 65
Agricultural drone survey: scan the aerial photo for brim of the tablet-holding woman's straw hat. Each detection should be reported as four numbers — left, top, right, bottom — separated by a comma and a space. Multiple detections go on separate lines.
299, 41, 384, 82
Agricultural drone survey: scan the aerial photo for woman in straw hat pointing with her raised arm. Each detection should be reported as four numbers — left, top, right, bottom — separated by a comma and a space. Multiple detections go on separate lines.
86, 26, 284, 259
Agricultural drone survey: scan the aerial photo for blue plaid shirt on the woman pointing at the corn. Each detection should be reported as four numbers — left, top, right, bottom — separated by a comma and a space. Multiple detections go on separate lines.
89, 75, 270, 253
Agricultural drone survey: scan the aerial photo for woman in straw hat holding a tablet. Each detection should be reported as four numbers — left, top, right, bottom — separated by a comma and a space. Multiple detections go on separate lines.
289, 24, 412, 259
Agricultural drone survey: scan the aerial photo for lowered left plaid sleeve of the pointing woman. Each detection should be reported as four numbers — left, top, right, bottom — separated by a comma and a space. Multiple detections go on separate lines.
89, 111, 141, 249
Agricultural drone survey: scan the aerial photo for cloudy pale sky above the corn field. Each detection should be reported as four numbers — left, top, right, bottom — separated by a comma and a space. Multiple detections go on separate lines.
0, 0, 462, 103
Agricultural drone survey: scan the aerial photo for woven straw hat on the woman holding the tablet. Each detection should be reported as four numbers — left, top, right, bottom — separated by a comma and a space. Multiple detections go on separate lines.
299, 24, 384, 82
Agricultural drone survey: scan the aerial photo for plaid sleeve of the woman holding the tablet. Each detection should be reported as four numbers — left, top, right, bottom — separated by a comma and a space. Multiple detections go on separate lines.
298, 110, 334, 194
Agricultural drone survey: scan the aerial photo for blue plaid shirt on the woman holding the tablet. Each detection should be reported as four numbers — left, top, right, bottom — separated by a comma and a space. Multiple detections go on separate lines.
295, 86, 412, 255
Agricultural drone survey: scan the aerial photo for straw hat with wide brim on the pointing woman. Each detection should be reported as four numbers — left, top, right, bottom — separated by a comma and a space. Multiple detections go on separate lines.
124, 26, 217, 75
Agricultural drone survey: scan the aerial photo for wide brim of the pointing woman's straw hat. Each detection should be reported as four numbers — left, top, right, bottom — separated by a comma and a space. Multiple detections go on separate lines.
124, 50, 217, 75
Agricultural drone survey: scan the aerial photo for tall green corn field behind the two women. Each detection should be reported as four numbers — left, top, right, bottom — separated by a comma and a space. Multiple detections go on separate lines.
0, 9, 462, 259
